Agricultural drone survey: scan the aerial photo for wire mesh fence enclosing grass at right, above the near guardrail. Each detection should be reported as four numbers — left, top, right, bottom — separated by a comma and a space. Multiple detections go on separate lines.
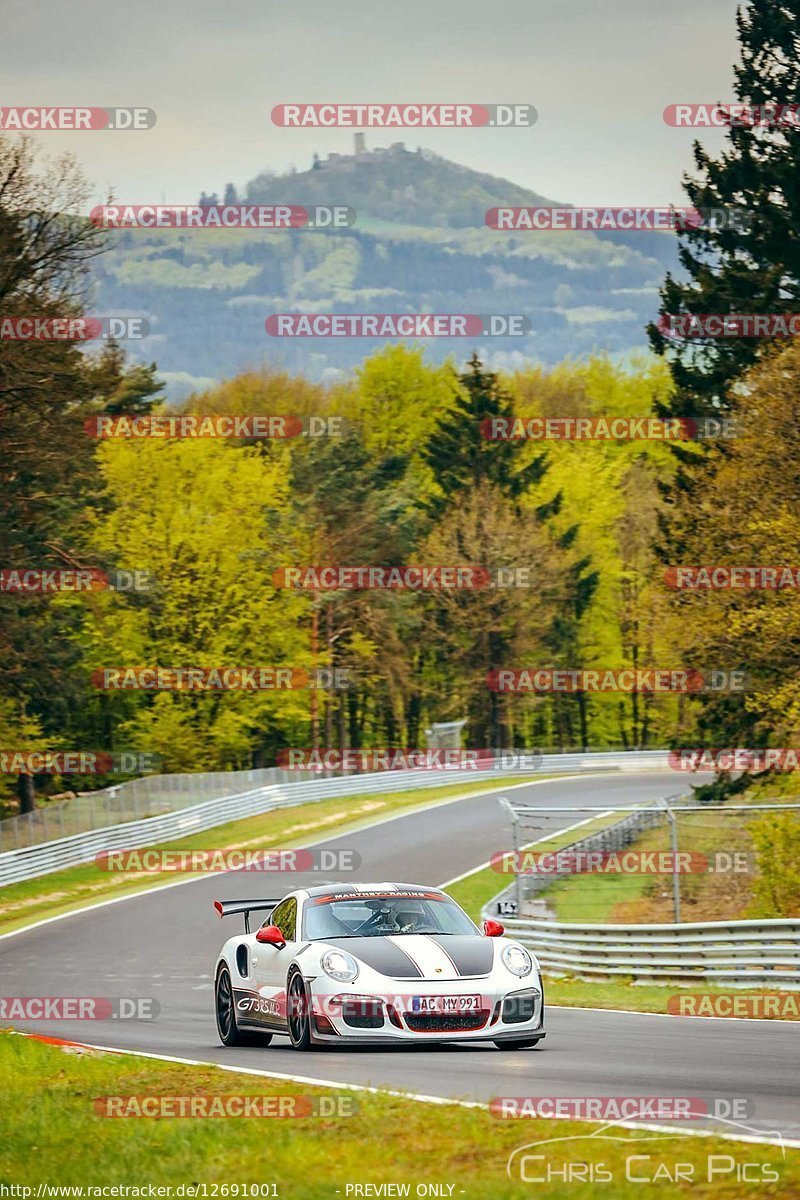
497, 797, 800, 925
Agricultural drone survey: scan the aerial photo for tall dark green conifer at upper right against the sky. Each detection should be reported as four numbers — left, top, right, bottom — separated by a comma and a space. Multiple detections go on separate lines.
649, 0, 800, 415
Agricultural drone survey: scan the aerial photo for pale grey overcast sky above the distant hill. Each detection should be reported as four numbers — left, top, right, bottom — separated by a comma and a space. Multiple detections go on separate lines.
0, 0, 736, 204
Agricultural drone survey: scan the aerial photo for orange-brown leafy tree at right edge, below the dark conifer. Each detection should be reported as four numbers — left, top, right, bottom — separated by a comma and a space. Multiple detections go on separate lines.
664, 346, 800, 746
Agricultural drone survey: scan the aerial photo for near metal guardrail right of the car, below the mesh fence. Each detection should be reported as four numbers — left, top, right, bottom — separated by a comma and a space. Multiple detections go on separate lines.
485, 901, 800, 988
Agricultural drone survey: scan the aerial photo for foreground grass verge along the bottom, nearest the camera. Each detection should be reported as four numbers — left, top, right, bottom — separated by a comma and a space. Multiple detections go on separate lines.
0, 1034, 800, 1200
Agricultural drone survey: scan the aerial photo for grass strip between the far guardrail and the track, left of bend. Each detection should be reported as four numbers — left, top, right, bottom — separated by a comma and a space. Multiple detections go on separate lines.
0, 775, 544, 934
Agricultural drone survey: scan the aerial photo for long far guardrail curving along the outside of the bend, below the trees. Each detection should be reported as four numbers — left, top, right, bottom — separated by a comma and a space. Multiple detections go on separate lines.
0, 750, 667, 886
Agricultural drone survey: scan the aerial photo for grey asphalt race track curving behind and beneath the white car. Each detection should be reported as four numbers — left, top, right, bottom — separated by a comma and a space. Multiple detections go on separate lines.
0, 772, 800, 1139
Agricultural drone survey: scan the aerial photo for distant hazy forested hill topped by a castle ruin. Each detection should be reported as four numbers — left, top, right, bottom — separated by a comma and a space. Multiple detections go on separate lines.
96, 143, 676, 397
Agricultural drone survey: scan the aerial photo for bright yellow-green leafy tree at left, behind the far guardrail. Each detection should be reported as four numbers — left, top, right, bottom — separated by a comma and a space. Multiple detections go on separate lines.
84, 440, 308, 770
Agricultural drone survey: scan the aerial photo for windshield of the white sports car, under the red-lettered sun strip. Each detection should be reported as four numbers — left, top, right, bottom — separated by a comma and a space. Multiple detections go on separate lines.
303, 892, 477, 938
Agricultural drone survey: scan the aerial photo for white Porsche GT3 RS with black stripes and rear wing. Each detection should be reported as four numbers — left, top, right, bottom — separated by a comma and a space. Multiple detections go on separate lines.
213, 883, 545, 1050
